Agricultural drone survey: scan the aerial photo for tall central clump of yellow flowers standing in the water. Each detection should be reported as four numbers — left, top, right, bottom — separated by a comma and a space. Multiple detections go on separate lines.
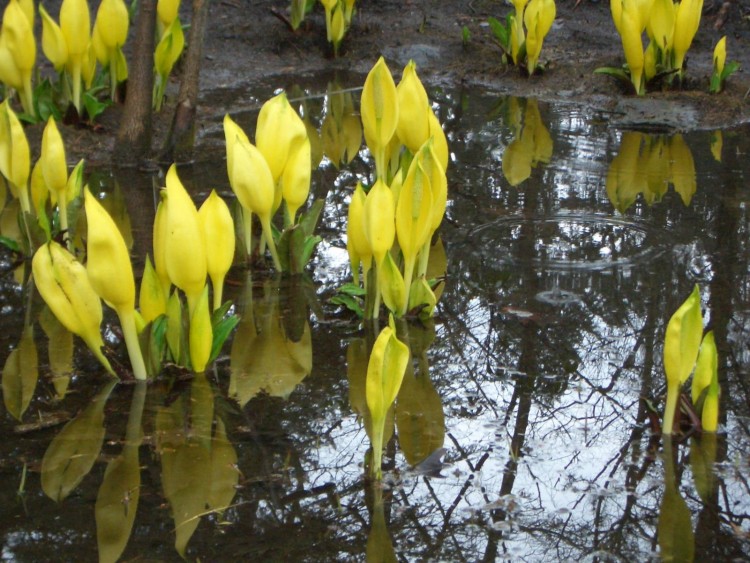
347, 57, 448, 317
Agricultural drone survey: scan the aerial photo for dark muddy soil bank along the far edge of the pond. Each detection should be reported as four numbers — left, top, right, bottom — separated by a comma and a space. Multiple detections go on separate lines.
67, 0, 750, 164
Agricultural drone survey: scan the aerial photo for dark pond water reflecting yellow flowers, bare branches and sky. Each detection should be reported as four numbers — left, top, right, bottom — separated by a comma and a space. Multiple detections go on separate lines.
0, 82, 750, 561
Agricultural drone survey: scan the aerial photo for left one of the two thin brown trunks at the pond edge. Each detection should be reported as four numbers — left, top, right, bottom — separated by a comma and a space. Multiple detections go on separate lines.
112, 0, 156, 165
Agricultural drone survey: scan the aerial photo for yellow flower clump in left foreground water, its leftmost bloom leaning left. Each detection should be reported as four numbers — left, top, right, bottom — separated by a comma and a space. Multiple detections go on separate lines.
32, 164, 234, 379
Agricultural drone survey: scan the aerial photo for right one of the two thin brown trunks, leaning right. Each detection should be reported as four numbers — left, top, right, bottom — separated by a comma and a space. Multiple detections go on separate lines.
159, 0, 209, 162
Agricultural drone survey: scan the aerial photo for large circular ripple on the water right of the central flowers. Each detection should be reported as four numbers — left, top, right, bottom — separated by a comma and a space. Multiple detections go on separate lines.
472, 214, 663, 270
